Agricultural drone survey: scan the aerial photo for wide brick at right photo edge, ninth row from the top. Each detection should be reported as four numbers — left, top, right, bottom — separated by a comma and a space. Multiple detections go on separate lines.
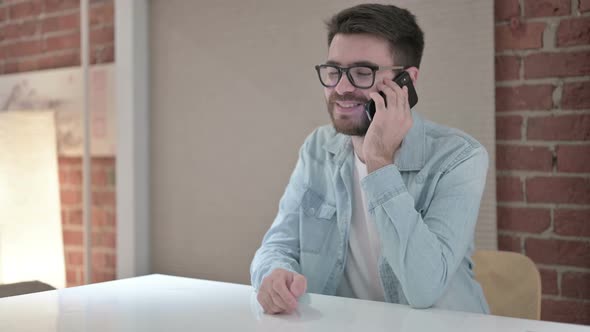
525, 238, 590, 268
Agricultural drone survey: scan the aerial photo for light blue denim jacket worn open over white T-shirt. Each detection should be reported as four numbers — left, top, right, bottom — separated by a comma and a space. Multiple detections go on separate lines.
250, 112, 489, 313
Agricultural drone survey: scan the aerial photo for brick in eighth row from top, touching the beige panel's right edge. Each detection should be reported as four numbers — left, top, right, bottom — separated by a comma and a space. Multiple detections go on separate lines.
497, 206, 551, 234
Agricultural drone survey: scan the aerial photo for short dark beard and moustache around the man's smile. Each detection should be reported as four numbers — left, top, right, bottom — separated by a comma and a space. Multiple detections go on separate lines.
327, 91, 371, 136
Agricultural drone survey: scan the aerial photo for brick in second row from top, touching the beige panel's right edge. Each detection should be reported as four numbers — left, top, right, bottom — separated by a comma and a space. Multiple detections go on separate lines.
494, 22, 545, 52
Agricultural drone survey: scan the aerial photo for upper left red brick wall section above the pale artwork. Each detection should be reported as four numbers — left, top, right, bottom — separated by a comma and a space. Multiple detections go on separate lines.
0, 0, 115, 74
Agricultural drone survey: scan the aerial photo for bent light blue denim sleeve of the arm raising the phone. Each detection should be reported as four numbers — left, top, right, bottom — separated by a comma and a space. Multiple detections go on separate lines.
361, 146, 488, 308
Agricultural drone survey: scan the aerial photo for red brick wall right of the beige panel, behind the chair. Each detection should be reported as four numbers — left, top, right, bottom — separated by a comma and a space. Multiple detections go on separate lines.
495, 0, 590, 324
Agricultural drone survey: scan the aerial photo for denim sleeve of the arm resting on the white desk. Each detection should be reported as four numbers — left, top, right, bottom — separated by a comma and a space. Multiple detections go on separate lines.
250, 142, 307, 290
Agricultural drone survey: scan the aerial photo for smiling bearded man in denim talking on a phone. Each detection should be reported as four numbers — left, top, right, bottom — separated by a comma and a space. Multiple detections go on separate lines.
250, 4, 489, 314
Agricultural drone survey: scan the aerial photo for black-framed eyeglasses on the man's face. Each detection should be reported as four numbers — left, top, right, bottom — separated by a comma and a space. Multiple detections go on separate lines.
315, 64, 404, 89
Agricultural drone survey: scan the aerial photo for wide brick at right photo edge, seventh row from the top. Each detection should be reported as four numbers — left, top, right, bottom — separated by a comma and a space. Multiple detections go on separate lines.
526, 177, 590, 204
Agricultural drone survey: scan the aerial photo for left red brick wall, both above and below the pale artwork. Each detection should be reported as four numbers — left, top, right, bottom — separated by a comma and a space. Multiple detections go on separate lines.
0, 0, 116, 286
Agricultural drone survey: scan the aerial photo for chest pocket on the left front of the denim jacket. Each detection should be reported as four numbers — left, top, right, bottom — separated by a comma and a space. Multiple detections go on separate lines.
299, 189, 337, 254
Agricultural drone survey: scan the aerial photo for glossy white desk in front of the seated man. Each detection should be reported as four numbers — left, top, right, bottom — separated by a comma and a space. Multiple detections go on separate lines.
0, 275, 590, 332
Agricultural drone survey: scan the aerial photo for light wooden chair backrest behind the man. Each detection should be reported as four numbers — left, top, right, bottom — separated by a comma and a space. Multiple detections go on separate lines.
473, 250, 541, 320
